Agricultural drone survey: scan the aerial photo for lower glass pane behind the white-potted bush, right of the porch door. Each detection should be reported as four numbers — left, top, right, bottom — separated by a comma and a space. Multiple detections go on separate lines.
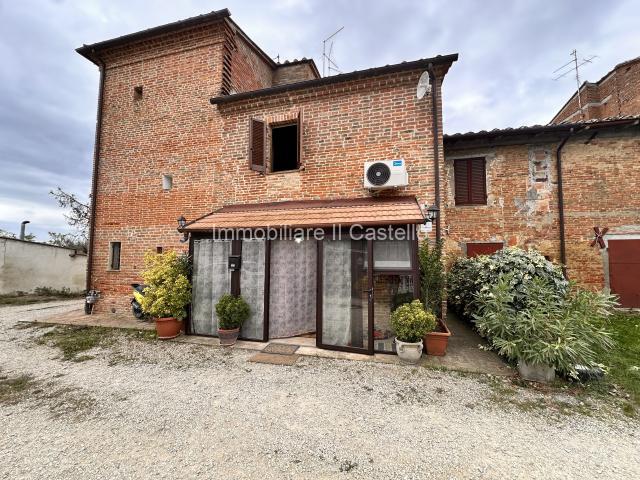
373, 273, 413, 352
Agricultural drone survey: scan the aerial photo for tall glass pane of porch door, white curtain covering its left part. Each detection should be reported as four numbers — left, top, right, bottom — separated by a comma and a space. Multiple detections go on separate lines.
322, 239, 368, 350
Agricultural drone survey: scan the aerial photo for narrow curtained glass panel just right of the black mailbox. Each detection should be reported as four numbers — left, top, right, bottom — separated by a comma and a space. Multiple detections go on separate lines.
240, 240, 265, 340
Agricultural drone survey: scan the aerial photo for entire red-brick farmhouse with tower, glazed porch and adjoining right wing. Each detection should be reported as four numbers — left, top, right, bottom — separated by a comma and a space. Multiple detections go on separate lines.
78, 10, 640, 353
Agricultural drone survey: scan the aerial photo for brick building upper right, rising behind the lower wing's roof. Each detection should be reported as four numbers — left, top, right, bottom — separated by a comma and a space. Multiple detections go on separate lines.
550, 57, 640, 124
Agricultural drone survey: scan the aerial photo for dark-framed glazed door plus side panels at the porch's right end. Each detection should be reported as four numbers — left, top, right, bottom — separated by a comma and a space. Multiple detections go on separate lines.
317, 234, 419, 354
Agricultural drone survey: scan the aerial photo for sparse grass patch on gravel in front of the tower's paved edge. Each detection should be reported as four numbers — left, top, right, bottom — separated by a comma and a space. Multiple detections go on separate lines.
36, 325, 156, 362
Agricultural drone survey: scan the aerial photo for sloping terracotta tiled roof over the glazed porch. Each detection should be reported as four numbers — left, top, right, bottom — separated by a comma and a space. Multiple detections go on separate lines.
182, 196, 424, 232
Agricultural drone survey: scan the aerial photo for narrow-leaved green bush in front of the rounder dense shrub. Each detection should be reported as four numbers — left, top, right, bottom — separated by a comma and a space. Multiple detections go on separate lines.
474, 273, 615, 375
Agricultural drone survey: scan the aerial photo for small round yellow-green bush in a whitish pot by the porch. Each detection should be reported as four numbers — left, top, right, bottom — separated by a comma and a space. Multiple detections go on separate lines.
391, 300, 436, 363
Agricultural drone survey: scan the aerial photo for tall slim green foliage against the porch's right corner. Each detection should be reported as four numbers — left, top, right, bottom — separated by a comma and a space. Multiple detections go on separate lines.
418, 240, 445, 317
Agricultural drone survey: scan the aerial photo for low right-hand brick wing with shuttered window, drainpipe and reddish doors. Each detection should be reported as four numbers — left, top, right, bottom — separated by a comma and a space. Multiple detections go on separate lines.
442, 115, 640, 307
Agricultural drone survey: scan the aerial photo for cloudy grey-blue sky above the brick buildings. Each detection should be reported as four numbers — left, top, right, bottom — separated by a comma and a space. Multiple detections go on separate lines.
0, 0, 640, 240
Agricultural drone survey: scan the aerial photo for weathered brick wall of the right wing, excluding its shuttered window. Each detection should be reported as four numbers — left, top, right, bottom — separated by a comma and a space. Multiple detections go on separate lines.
445, 127, 640, 288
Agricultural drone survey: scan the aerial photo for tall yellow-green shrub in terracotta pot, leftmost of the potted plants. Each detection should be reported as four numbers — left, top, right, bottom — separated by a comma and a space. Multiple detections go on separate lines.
141, 251, 191, 340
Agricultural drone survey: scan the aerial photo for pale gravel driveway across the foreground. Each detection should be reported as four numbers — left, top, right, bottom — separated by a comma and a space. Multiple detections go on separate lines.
0, 301, 640, 480
